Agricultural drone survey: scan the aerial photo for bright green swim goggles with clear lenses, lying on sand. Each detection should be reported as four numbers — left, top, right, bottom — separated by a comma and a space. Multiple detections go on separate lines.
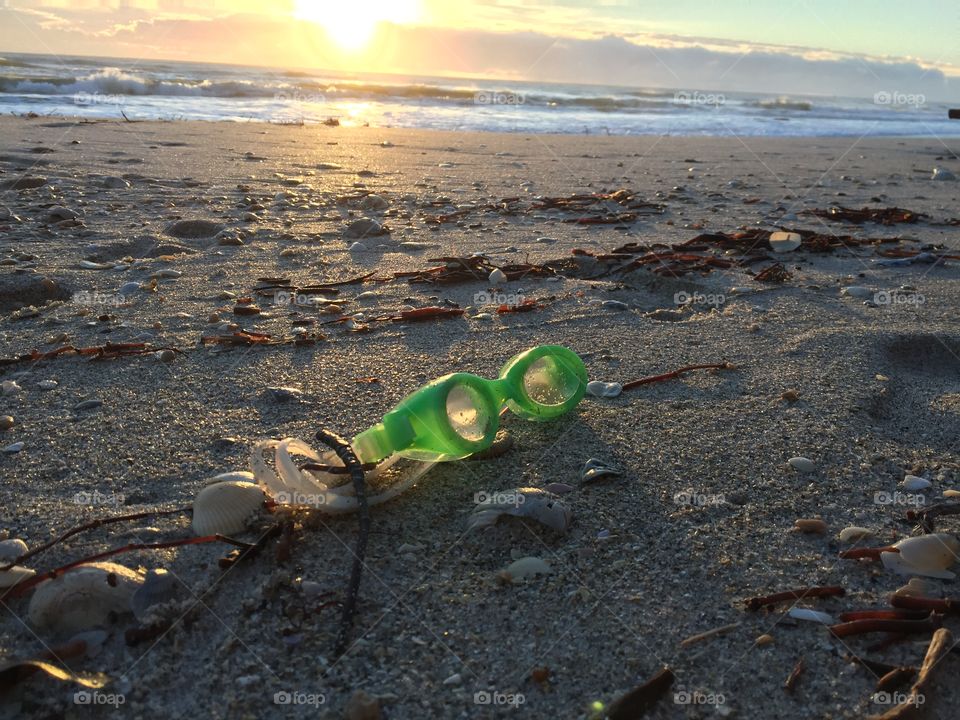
353, 345, 587, 463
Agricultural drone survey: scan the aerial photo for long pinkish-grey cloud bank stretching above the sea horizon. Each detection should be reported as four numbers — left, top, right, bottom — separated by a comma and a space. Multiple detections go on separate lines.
0, 5, 960, 100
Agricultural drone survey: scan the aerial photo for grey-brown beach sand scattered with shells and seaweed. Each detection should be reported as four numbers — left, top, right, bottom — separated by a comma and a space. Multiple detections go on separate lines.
0, 118, 960, 720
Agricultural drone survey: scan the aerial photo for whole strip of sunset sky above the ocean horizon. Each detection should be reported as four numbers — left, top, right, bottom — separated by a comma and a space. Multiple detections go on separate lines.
0, 0, 960, 103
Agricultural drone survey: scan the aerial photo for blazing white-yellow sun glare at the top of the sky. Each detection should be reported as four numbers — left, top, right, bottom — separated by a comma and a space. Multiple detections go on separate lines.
294, 0, 421, 52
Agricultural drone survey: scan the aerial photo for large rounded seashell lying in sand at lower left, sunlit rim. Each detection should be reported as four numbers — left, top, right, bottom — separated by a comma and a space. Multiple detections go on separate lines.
28, 562, 143, 634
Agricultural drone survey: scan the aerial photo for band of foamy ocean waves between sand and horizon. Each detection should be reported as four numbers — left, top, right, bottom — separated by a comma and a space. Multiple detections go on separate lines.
0, 54, 960, 137
